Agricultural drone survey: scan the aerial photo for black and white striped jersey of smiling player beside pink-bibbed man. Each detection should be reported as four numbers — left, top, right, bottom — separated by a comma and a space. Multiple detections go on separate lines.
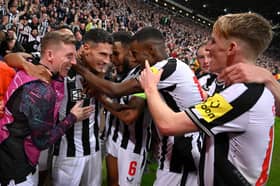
54, 71, 100, 157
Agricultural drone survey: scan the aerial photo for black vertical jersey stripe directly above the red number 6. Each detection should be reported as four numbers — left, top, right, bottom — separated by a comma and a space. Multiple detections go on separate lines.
133, 111, 144, 154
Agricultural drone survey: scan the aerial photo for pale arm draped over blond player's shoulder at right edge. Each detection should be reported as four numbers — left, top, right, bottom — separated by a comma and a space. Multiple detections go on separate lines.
218, 63, 280, 116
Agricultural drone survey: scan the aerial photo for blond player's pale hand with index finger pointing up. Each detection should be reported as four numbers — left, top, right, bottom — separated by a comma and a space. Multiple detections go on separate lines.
139, 60, 163, 92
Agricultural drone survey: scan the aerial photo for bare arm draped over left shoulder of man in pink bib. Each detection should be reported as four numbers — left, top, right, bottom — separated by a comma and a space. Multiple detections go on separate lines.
4, 53, 52, 83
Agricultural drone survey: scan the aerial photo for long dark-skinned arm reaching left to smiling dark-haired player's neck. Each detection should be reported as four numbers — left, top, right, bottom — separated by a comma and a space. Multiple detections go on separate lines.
73, 64, 143, 97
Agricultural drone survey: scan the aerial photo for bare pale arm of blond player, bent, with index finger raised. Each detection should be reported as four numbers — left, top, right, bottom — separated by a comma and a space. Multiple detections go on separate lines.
140, 62, 198, 136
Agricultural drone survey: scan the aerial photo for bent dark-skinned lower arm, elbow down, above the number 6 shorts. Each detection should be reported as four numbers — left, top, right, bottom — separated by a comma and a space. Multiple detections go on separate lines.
100, 96, 146, 125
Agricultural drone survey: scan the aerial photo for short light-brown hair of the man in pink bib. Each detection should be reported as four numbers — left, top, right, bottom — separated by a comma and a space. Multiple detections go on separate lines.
41, 31, 76, 56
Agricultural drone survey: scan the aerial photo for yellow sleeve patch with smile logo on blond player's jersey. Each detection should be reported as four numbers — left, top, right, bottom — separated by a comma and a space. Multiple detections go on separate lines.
195, 94, 233, 123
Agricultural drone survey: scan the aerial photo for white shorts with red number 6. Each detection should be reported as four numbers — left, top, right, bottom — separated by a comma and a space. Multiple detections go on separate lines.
118, 147, 147, 186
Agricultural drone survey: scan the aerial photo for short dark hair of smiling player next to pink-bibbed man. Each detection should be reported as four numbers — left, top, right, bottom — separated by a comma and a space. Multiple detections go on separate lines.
83, 28, 113, 44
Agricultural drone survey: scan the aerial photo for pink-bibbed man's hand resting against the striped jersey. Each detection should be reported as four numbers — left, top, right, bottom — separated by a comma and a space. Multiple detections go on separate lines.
70, 101, 94, 121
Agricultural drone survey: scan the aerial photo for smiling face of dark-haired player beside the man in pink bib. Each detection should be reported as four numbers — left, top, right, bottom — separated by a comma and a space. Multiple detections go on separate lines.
83, 43, 112, 73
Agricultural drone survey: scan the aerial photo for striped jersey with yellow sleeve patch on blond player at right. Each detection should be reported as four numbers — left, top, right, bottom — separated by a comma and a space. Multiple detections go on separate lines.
185, 81, 274, 186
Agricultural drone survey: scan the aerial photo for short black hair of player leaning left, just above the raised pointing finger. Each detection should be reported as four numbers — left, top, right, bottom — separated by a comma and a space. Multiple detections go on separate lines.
132, 27, 164, 43
